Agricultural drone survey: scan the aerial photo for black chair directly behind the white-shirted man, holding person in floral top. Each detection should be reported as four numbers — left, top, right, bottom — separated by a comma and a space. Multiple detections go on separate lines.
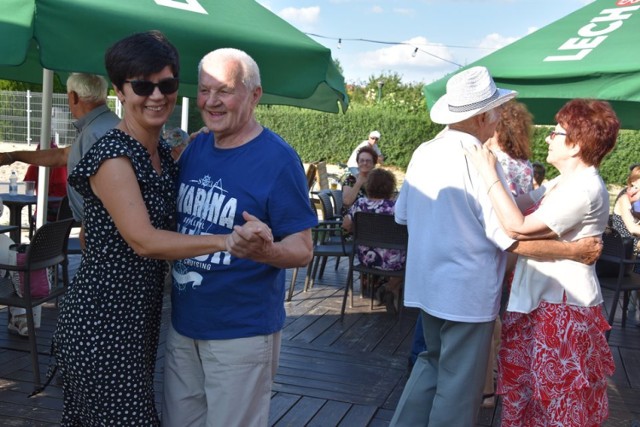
340, 212, 409, 318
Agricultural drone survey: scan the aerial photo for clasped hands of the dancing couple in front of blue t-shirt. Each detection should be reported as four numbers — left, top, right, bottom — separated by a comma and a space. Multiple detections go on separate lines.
226, 211, 274, 261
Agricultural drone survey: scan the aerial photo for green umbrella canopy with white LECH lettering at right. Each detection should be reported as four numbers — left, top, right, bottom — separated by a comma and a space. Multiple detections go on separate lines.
423, 0, 640, 129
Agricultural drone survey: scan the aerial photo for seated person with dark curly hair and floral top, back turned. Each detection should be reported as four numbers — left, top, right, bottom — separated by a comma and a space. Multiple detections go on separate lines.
342, 169, 407, 313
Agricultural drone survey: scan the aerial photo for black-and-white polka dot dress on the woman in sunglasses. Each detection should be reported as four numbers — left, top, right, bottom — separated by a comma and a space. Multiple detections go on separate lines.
54, 129, 177, 426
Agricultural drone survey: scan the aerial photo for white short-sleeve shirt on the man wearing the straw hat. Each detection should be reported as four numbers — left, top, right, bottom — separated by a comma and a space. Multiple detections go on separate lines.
395, 130, 514, 323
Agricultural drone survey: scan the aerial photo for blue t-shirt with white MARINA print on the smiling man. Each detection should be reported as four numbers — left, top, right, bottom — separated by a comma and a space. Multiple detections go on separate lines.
171, 129, 317, 340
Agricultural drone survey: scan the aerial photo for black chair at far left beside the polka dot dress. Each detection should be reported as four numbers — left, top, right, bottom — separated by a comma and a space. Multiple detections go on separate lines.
0, 219, 73, 387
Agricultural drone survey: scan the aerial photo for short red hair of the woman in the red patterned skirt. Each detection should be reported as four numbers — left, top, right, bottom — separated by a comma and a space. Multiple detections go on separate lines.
556, 99, 620, 167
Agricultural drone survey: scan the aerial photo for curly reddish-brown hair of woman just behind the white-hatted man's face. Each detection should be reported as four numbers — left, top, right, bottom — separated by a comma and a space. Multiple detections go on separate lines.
496, 100, 533, 160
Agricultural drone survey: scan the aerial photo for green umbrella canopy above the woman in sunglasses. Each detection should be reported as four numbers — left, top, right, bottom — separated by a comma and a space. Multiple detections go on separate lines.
0, 0, 348, 112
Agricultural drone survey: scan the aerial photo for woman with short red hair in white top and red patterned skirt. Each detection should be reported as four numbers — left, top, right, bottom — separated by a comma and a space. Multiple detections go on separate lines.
468, 99, 620, 427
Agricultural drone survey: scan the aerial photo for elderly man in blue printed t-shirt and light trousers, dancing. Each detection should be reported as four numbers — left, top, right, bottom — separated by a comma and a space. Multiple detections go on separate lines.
162, 49, 317, 427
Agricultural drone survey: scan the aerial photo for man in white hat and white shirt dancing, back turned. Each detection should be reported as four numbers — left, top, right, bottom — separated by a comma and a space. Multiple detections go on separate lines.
391, 67, 601, 427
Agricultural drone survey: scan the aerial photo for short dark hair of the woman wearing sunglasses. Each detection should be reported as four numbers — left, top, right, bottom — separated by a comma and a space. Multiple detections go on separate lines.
104, 30, 180, 90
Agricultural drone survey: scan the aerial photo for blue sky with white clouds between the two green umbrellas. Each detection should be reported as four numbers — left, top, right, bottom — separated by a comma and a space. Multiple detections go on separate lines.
258, 0, 592, 83
